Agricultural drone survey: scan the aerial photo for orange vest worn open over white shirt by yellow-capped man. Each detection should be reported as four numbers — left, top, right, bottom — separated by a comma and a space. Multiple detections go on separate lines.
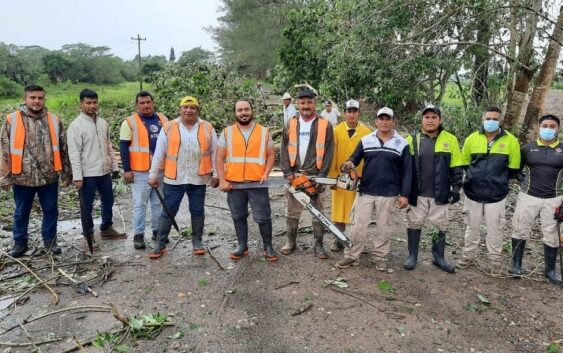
164, 119, 213, 180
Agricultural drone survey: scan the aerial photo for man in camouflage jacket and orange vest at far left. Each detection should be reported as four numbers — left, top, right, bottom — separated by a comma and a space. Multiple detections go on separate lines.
0, 85, 72, 257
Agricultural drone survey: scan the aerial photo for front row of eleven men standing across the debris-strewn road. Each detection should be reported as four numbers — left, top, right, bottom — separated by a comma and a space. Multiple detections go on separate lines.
0, 86, 563, 283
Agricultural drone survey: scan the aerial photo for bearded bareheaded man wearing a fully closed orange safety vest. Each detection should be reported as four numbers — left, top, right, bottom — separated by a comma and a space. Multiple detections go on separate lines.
216, 100, 278, 262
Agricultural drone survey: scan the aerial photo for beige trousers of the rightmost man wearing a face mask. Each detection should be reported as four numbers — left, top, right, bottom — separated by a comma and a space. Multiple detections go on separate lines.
512, 192, 563, 248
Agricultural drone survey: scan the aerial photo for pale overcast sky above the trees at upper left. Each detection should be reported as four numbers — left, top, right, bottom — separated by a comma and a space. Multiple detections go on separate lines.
0, 0, 218, 59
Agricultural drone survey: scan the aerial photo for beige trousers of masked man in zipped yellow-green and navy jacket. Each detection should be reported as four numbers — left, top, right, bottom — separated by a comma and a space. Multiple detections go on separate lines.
463, 196, 506, 262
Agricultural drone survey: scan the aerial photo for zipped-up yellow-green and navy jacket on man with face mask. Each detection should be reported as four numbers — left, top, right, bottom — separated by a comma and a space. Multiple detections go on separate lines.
461, 128, 520, 203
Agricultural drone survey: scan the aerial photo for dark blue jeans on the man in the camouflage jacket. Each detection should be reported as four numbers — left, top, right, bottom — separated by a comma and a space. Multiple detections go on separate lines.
12, 182, 59, 245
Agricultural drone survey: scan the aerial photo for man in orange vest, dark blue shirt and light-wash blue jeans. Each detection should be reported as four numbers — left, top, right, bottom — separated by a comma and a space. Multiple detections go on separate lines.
119, 91, 168, 249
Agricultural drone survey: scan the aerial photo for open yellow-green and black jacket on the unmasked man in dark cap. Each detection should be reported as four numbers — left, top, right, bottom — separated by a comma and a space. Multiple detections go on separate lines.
406, 127, 463, 206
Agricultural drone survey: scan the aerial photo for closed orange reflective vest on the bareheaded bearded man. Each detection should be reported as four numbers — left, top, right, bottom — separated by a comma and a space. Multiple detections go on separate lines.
223, 123, 270, 182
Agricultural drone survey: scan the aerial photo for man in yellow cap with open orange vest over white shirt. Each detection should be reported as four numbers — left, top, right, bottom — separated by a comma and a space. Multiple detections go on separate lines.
148, 96, 219, 259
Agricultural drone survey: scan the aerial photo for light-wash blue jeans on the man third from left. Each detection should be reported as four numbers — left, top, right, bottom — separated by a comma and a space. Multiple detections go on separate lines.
131, 172, 163, 234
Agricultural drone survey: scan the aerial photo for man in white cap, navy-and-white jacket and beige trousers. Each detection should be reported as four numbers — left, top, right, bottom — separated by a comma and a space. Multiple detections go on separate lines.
336, 107, 412, 271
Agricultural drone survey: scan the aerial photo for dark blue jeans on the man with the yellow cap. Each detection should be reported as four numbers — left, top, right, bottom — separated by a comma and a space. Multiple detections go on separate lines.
158, 183, 206, 237
